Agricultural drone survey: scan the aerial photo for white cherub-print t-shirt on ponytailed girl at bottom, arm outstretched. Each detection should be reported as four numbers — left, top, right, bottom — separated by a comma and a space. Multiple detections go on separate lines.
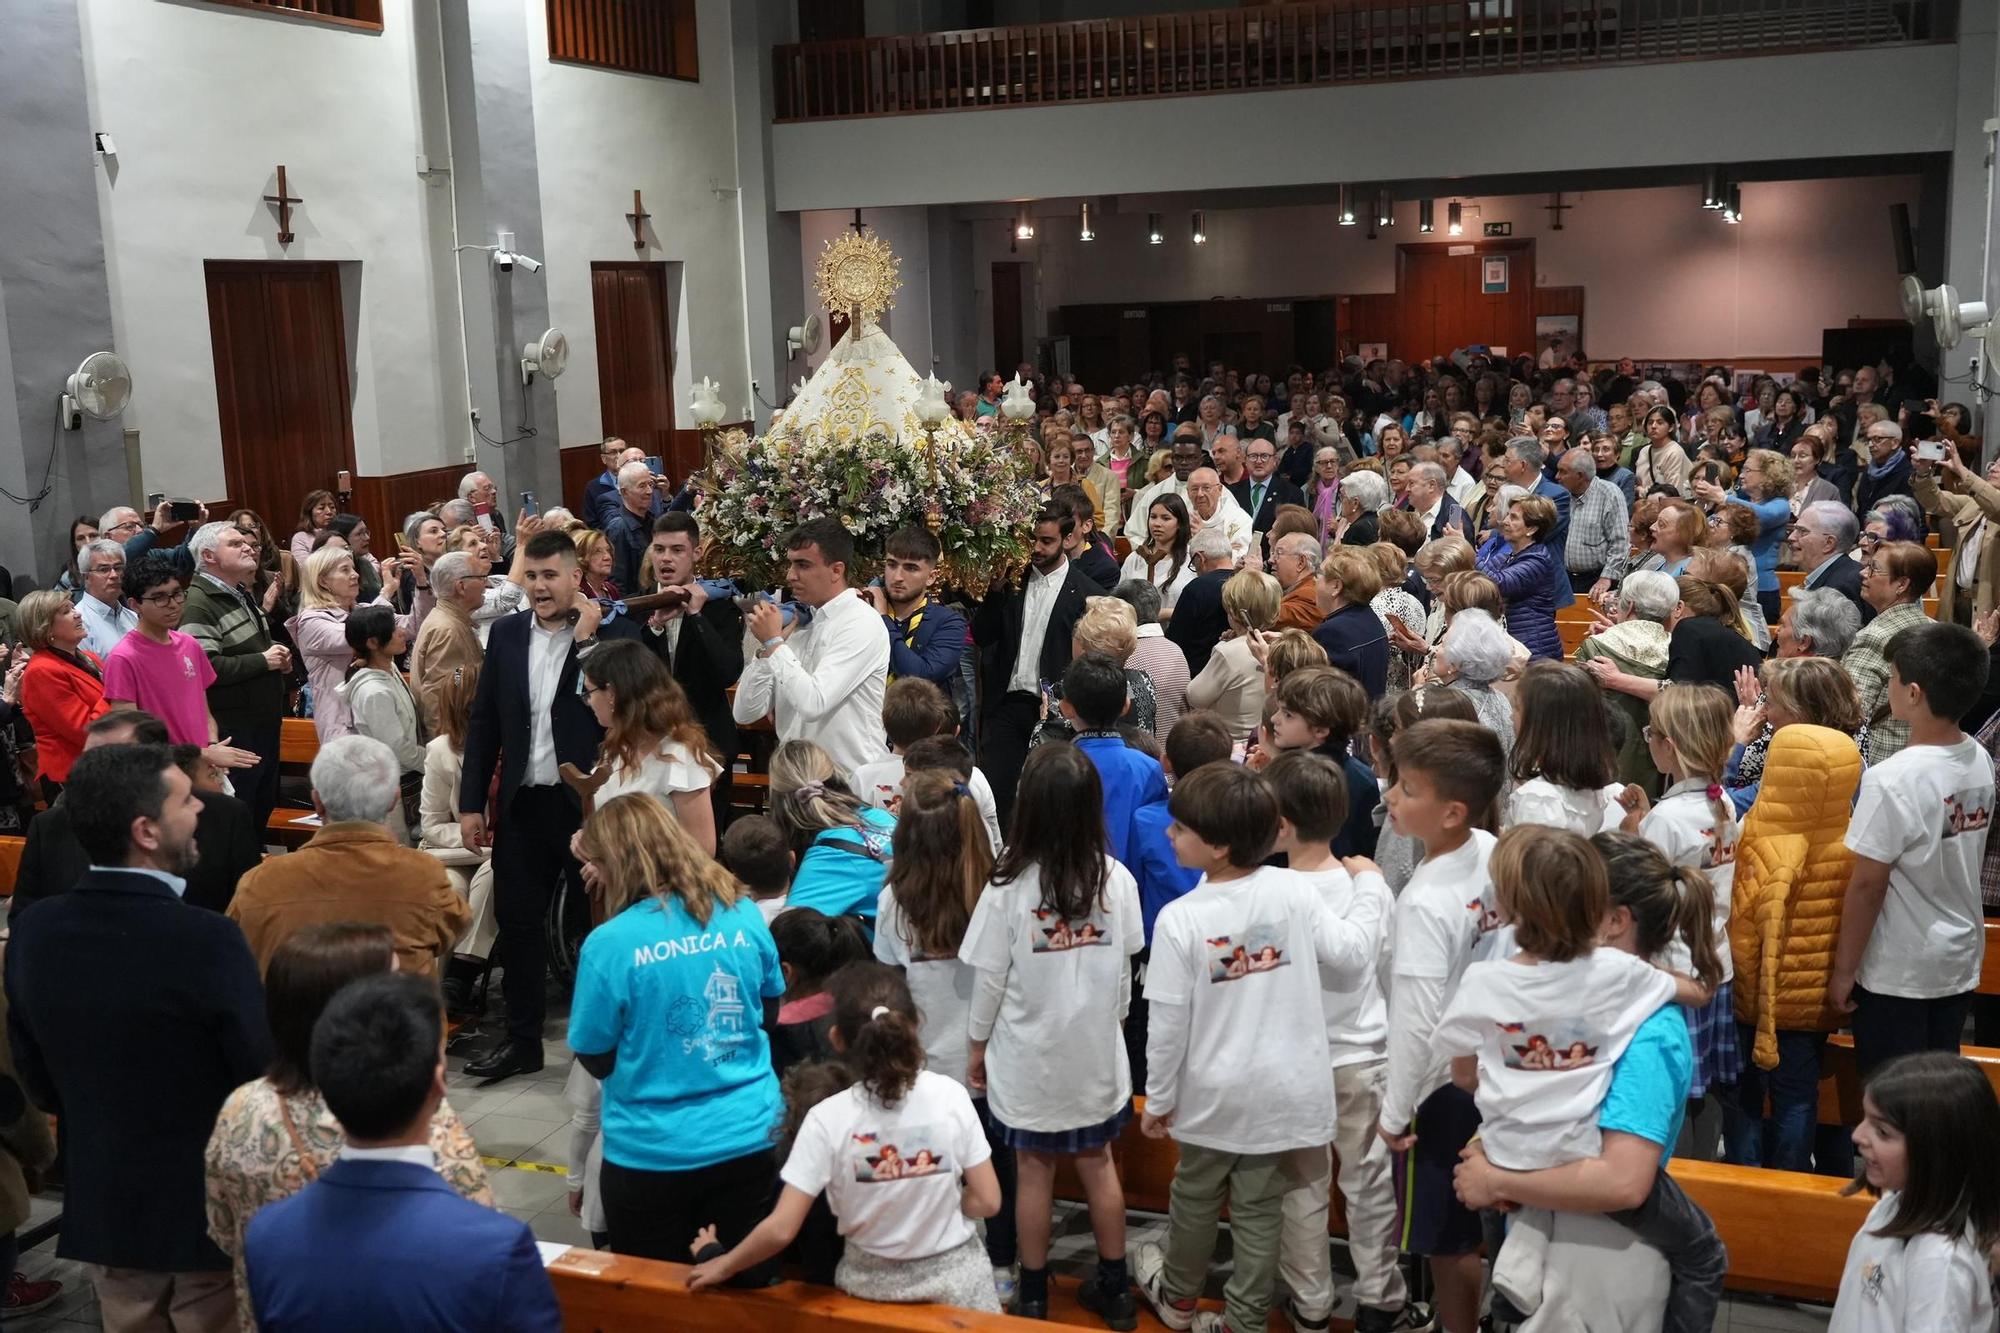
778, 1069, 992, 1259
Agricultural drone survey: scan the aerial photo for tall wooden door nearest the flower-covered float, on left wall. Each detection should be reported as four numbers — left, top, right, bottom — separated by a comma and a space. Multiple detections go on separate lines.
590, 264, 684, 482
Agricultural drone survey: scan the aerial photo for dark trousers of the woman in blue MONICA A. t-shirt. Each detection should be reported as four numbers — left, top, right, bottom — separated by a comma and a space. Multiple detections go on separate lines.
600, 1149, 778, 1287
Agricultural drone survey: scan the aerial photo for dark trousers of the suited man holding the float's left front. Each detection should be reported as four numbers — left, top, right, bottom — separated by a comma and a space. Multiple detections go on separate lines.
494, 787, 584, 1048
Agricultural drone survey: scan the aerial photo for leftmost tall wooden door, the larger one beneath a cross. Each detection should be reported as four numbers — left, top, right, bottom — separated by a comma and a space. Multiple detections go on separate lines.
204, 260, 354, 532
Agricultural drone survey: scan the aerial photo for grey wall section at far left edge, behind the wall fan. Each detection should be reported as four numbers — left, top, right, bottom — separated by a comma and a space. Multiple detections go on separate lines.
0, 0, 126, 578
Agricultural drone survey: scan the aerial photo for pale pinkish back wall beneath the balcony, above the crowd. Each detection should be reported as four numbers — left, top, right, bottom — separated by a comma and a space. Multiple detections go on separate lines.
1000, 176, 1918, 360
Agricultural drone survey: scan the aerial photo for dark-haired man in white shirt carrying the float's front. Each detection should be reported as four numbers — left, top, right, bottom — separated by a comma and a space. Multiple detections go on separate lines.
730, 518, 888, 773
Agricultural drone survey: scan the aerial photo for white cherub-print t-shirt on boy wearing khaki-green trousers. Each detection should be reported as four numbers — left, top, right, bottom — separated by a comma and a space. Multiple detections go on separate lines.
1146, 867, 1390, 1153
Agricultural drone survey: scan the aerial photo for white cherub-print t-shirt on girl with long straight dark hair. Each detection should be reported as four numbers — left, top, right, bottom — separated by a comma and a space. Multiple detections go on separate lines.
958, 857, 1146, 1135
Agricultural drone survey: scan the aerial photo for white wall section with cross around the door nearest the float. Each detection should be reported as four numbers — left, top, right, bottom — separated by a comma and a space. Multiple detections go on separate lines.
524, 0, 752, 426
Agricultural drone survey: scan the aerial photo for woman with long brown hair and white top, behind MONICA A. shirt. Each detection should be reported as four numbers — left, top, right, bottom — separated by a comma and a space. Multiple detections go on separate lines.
580, 638, 722, 844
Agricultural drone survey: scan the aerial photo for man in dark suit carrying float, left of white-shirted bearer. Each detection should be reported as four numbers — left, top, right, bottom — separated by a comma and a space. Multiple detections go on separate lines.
626, 510, 744, 829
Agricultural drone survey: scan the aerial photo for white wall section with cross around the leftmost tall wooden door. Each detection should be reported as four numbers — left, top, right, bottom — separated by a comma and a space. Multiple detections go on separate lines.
78, 0, 464, 492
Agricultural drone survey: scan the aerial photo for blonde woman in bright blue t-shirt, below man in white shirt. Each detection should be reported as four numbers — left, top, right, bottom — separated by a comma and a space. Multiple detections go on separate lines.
770, 741, 896, 931
